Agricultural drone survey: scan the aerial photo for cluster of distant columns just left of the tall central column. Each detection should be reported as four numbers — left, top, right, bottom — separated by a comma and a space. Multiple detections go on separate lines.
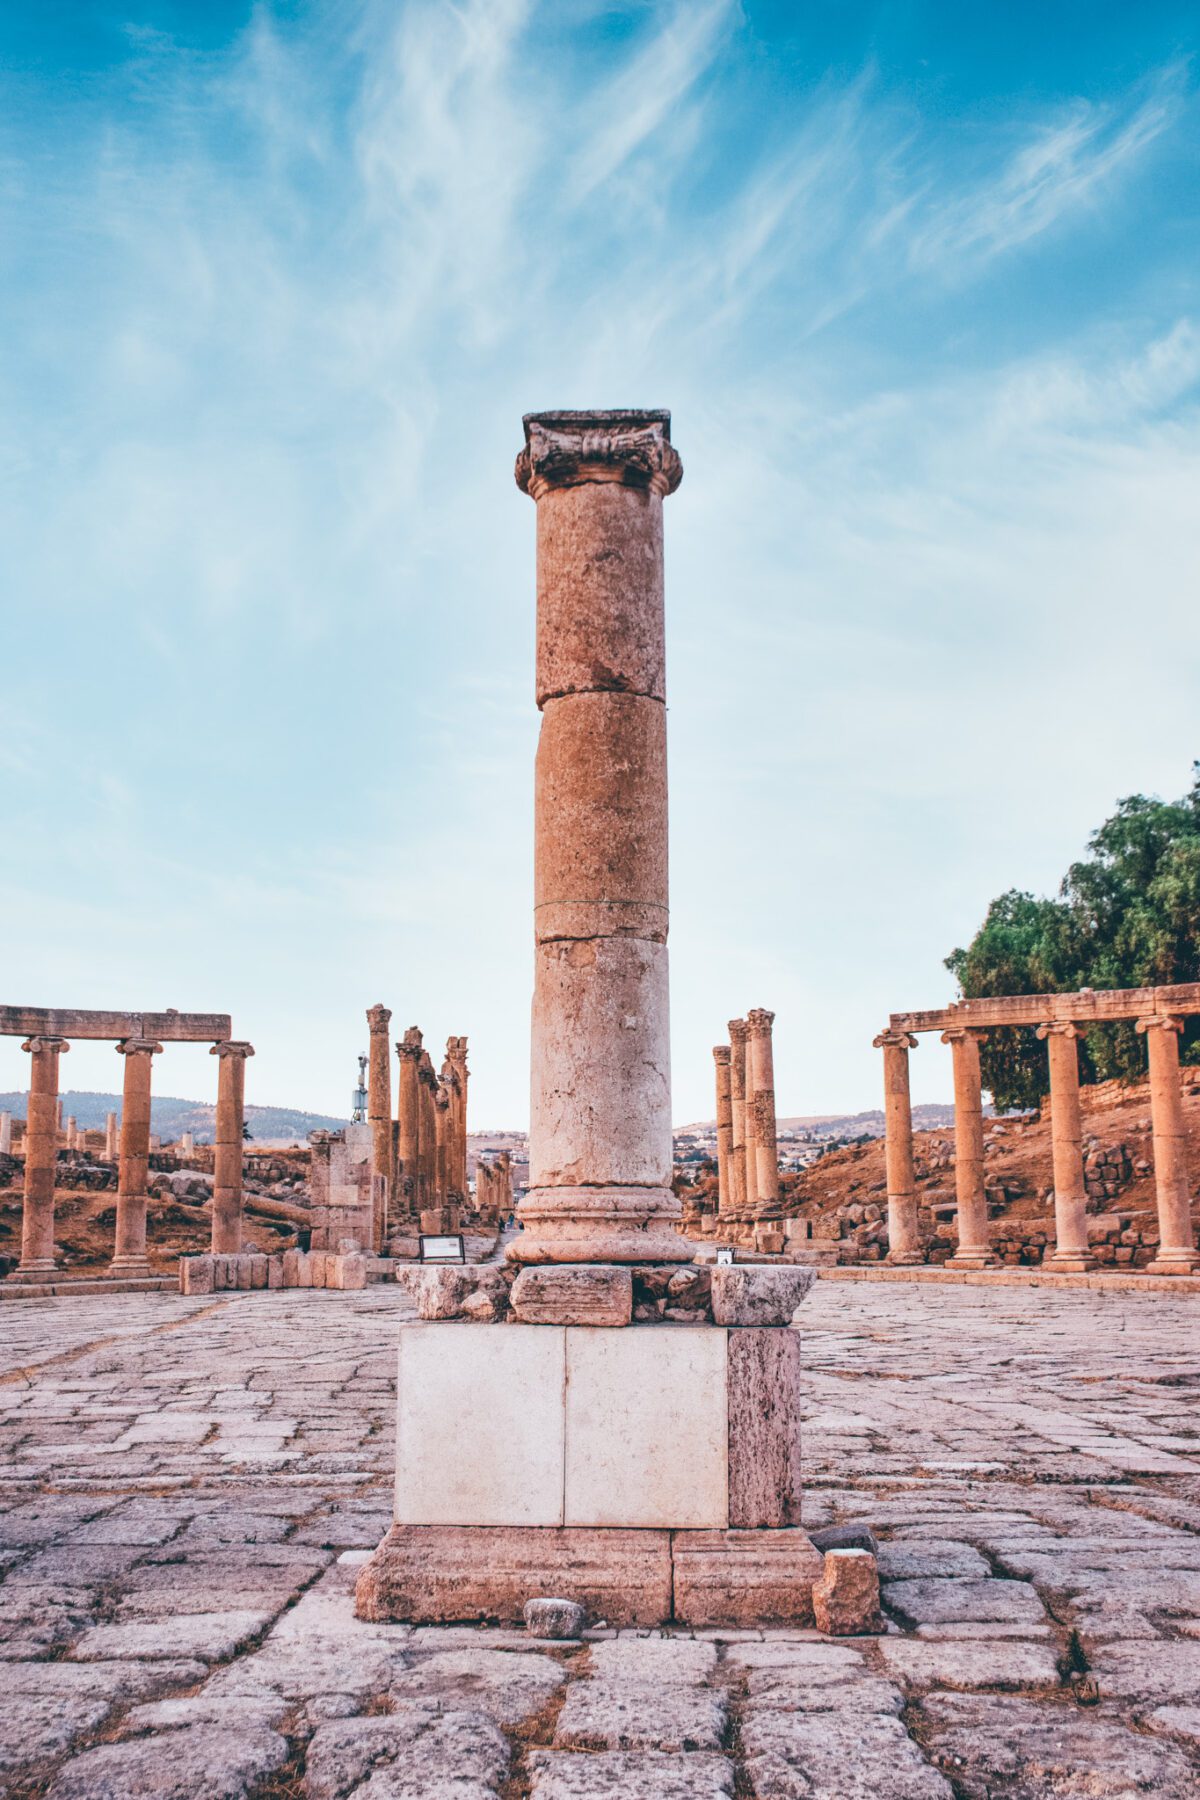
367, 1006, 470, 1240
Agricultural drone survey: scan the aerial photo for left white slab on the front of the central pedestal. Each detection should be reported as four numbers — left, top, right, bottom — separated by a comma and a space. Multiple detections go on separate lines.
396, 1323, 567, 1526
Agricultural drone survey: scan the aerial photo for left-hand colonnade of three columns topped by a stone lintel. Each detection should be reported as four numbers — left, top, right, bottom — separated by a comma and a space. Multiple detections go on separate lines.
0, 1006, 254, 1282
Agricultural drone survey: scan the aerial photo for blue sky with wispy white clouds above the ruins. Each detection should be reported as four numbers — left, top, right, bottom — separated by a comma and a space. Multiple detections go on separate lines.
0, 0, 1200, 1125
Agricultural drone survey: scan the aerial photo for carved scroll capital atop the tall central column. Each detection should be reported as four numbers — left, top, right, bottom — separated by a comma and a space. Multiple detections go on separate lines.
515, 410, 684, 500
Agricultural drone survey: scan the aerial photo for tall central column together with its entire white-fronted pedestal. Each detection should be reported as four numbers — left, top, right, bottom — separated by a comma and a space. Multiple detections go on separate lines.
358, 412, 831, 1627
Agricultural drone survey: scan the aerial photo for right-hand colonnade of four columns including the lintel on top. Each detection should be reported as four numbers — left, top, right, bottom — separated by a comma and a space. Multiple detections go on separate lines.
874, 985, 1200, 1274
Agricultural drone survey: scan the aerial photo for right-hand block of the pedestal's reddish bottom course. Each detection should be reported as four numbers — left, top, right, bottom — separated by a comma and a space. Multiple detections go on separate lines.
671, 1530, 824, 1627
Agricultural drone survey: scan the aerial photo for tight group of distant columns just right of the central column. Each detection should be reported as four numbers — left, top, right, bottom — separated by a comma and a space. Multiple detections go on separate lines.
712, 1006, 779, 1220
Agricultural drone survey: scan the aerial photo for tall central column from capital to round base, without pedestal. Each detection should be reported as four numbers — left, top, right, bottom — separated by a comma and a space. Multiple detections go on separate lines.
507, 412, 691, 1262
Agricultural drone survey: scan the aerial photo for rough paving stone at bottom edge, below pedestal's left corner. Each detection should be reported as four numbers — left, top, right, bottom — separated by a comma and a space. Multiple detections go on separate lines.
304, 1703, 509, 1800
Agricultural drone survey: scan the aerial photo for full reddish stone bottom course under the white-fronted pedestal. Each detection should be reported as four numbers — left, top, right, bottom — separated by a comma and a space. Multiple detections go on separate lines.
354, 1525, 824, 1629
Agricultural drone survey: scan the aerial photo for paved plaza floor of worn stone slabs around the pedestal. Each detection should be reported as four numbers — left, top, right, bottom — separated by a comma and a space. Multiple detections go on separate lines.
0, 1282, 1200, 1800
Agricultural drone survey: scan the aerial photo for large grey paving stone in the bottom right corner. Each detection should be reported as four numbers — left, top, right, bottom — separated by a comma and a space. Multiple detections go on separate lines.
921, 1694, 1200, 1800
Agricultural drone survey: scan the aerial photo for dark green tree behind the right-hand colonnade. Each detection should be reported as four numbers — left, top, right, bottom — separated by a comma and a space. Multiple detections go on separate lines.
946, 763, 1200, 1111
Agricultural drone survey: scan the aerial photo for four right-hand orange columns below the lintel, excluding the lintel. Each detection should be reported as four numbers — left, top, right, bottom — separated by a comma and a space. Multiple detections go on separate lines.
874, 1013, 1200, 1274
